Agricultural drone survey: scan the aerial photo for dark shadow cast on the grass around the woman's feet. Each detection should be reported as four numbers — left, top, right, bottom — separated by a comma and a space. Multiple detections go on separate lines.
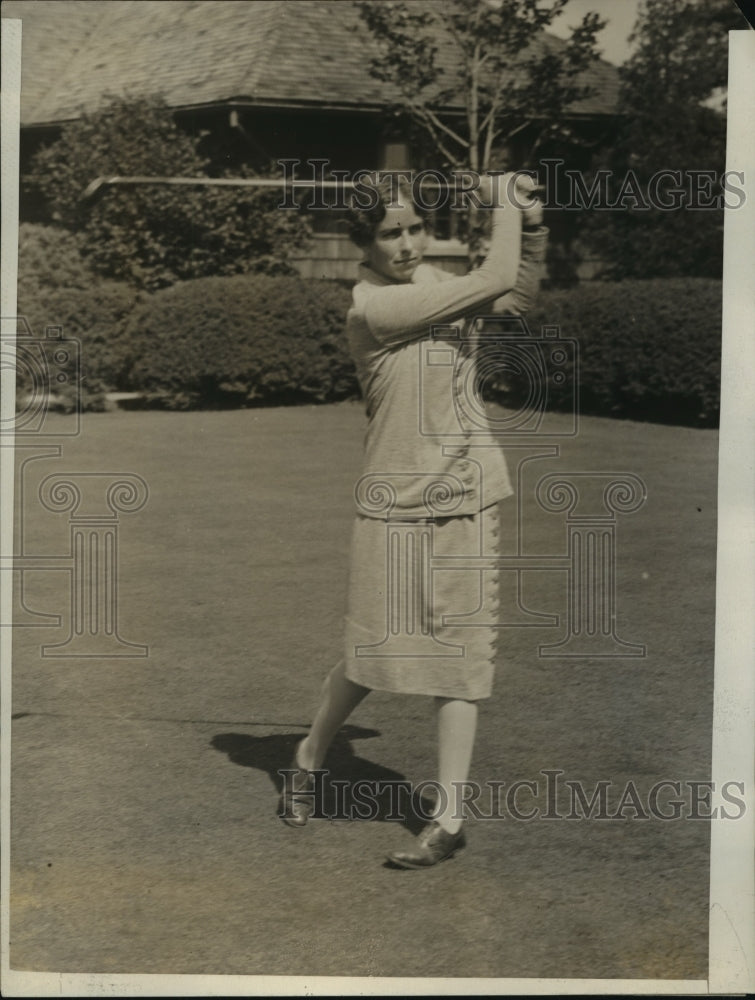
210, 725, 432, 834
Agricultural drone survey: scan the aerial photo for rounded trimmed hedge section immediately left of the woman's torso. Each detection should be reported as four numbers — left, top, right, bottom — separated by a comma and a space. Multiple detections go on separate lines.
125, 275, 358, 409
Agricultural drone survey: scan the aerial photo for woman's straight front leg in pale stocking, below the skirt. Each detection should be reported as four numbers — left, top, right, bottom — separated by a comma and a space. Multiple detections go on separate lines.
434, 698, 477, 833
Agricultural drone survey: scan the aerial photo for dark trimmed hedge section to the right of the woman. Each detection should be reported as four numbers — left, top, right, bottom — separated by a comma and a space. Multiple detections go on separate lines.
498, 278, 721, 427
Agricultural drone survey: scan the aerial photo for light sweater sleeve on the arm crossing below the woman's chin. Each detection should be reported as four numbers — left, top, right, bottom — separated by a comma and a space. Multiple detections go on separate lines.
364, 205, 522, 346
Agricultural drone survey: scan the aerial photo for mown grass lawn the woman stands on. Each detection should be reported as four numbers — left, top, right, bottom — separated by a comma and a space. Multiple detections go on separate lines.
10, 403, 717, 979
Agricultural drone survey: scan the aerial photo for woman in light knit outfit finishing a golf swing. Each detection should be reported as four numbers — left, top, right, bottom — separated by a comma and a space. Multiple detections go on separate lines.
281, 175, 547, 868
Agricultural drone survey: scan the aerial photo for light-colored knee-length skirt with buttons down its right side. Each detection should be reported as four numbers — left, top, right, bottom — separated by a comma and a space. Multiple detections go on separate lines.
345, 505, 498, 701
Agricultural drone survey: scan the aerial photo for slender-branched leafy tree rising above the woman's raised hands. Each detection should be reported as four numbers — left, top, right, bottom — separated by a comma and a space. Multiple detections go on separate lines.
357, 0, 605, 172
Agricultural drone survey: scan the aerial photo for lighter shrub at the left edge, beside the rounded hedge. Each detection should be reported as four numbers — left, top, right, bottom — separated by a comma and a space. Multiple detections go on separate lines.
18, 223, 137, 409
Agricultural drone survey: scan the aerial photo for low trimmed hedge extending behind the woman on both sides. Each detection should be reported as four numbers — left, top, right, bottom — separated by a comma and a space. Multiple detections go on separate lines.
118, 275, 721, 427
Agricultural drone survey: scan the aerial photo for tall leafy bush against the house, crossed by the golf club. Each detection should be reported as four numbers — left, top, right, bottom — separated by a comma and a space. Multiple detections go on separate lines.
24, 99, 307, 289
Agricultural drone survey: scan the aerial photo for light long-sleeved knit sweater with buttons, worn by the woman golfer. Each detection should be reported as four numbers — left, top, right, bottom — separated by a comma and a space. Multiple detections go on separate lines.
346, 222, 548, 520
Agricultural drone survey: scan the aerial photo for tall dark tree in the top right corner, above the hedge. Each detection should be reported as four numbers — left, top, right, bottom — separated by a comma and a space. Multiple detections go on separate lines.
587, 0, 746, 278
